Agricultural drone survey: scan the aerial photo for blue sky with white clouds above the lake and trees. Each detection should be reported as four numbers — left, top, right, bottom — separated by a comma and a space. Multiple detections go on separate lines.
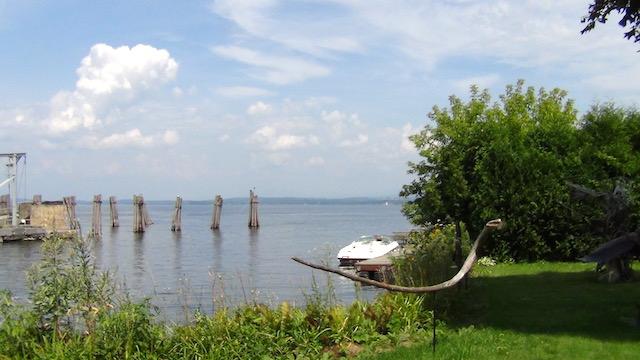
0, 0, 640, 200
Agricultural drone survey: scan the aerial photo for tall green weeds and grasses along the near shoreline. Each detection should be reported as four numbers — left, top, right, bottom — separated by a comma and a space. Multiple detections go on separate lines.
0, 236, 432, 359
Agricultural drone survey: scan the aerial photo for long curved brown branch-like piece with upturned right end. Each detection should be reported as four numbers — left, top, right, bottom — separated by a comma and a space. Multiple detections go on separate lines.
291, 219, 504, 294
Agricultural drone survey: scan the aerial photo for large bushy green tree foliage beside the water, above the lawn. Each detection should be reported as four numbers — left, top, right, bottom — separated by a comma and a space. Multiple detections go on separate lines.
401, 81, 638, 260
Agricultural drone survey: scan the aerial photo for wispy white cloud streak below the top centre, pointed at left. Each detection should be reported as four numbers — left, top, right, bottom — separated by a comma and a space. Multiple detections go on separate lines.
212, 46, 330, 85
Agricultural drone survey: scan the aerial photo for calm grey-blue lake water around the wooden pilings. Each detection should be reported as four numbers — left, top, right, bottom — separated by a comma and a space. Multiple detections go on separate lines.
0, 199, 410, 319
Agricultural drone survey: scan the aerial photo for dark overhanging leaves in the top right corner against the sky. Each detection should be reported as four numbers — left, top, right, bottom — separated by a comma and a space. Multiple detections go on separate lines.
581, 0, 640, 42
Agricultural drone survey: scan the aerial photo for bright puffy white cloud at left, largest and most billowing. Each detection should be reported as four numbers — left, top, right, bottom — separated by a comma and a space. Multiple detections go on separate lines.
45, 44, 178, 133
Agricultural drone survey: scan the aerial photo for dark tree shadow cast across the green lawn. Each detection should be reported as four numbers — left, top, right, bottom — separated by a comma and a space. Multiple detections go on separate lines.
448, 264, 640, 341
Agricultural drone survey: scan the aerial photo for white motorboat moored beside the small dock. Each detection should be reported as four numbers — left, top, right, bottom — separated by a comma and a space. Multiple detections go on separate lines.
338, 235, 400, 266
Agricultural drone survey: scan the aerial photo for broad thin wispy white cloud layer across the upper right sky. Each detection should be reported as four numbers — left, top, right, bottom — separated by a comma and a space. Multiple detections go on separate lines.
212, 0, 637, 101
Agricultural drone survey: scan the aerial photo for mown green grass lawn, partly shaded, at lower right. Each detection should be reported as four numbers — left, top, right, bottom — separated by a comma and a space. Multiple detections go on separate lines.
374, 263, 640, 360
